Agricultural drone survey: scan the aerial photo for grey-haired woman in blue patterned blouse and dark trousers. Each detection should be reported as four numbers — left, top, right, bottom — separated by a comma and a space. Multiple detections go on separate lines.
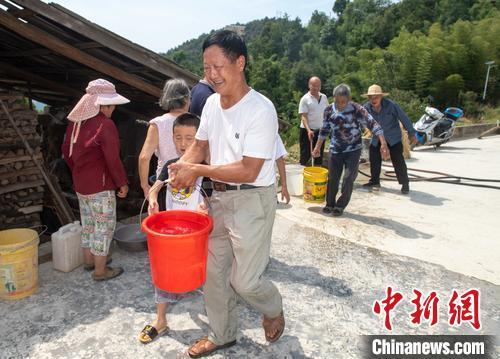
313, 84, 388, 217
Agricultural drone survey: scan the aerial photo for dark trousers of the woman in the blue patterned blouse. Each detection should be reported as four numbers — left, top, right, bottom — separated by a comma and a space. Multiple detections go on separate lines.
326, 149, 361, 208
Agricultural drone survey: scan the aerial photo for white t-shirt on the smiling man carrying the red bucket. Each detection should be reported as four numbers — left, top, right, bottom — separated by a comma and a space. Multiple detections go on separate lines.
196, 89, 278, 186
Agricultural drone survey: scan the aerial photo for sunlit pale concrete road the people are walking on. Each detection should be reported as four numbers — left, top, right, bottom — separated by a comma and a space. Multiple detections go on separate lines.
0, 137, 500, 359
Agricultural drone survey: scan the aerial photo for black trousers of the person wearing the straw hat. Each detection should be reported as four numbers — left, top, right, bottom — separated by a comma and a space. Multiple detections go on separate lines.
370, 142, 409, 184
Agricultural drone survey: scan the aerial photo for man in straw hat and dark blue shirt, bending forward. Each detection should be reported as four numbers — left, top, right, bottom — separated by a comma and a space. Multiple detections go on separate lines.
363, 85, 416, 194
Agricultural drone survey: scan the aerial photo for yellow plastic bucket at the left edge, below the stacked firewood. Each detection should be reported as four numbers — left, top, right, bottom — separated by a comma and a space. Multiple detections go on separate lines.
0, 228, 39, 300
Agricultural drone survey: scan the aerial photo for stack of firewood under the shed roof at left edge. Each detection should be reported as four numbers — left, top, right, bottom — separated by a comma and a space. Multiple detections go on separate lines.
0, 92, 44, 229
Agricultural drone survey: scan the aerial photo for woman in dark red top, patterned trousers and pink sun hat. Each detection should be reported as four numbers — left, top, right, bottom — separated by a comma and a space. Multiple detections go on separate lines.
62, 79, 130, 281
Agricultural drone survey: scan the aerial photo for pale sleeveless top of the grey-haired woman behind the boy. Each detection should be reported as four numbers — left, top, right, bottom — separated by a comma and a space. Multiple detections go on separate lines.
149, 113, 179, 177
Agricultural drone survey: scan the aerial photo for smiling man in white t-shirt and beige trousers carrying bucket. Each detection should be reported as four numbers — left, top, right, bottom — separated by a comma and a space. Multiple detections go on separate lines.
169, 30, 285, 358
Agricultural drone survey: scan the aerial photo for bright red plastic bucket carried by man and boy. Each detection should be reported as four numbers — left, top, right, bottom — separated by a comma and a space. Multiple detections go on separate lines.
142, 210, 213, 293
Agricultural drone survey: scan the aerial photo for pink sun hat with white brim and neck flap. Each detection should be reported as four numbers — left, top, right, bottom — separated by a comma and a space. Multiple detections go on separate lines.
68, 79, 130, 123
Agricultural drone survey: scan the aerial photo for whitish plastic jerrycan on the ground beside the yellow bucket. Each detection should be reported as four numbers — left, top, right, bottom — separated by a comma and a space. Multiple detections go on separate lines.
52, 221, 83, 272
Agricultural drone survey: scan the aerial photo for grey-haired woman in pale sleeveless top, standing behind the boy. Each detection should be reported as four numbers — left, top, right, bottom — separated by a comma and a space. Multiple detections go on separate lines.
139, 79, 191, 211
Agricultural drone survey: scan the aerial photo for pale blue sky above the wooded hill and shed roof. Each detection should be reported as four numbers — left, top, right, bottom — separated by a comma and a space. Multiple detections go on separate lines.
44, 0, 335, 52
